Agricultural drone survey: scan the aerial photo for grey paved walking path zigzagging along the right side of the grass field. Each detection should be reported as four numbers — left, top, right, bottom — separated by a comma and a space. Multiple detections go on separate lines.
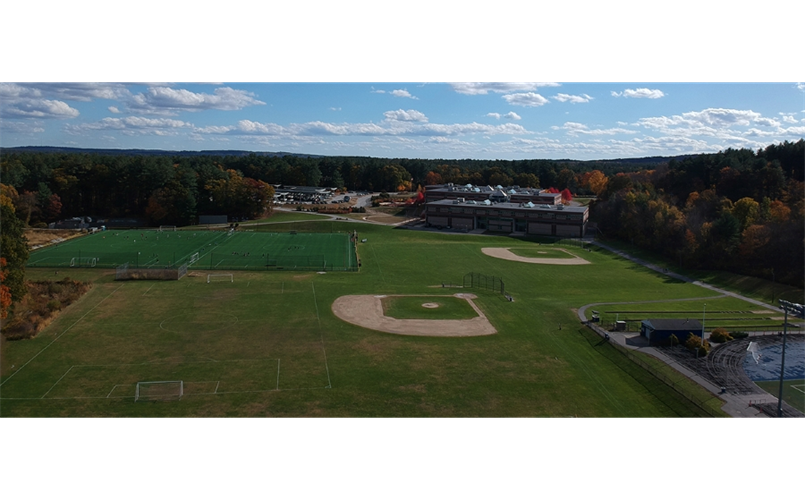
578, 239, 800, 418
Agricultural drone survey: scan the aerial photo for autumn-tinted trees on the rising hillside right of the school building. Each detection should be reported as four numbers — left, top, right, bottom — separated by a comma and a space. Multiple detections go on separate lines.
588, 140, 805, 287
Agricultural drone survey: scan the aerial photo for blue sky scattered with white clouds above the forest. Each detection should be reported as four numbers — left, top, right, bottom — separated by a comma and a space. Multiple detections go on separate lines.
0, 82, 805, 160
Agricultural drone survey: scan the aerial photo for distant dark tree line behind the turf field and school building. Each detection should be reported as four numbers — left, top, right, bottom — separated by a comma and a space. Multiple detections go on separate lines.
0, 148, 676, 226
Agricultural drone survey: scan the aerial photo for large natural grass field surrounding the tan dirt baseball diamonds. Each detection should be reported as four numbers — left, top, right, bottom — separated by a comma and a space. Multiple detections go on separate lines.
0, 221, 780, 417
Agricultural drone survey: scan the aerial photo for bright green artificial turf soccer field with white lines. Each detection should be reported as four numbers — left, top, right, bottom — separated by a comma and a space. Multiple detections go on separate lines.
27, 230, 358, 271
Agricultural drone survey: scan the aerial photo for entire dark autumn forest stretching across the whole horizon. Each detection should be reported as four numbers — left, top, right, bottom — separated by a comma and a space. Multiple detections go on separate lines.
0, 140, 805, 287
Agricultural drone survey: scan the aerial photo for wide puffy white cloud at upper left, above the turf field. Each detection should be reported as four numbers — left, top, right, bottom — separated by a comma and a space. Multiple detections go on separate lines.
129, 87, 265, 114
